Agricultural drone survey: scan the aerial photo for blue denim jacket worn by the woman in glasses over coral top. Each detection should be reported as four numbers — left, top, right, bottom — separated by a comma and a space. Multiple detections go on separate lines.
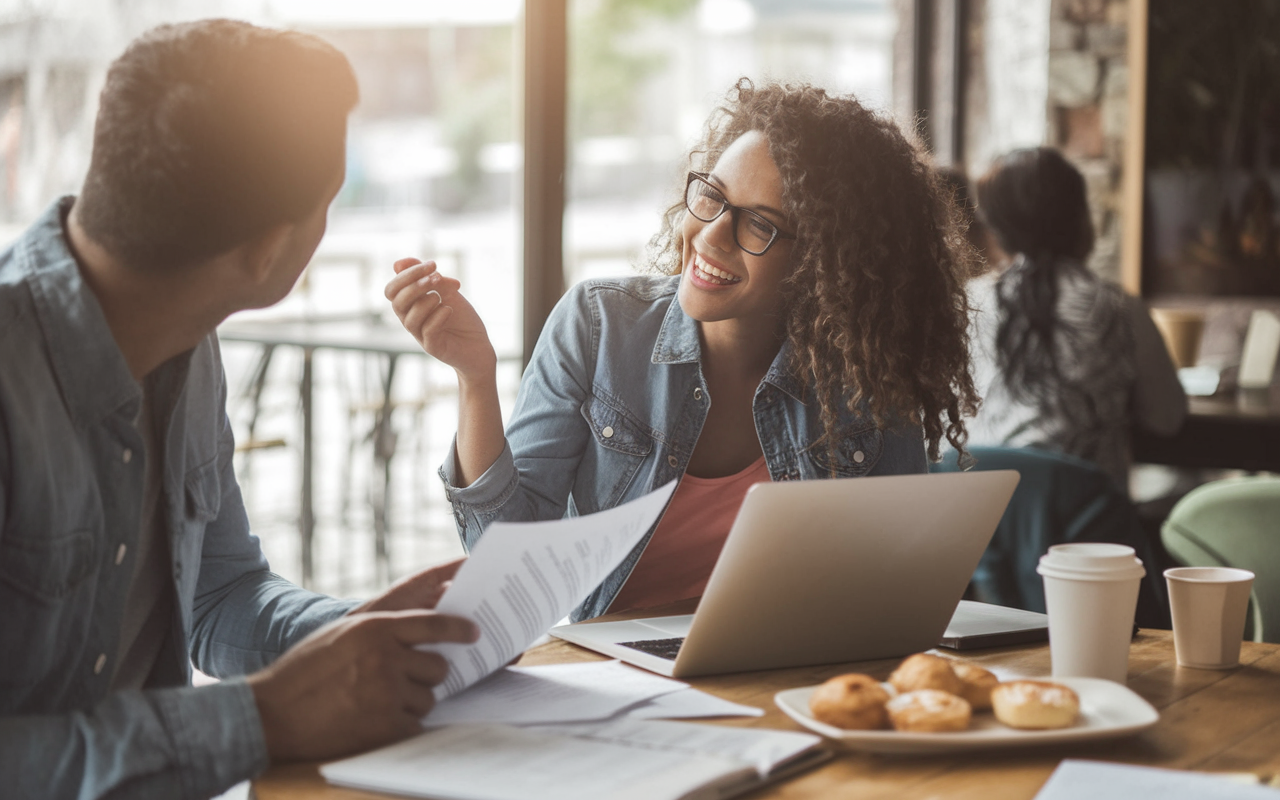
440, 276, 928, 621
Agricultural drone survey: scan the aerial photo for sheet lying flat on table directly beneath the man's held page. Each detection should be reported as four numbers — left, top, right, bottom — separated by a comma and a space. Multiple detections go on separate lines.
422, 660, 691, 727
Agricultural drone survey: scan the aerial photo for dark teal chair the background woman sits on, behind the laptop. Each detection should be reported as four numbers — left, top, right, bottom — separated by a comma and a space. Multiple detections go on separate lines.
929, 447, 1171, 628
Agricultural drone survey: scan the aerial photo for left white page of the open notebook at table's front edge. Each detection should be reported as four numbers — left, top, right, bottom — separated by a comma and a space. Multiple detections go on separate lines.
320, 723, 750, 800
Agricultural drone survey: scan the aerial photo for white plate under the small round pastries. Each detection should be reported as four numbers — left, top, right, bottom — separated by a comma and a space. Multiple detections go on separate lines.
773, 678, 1160, 753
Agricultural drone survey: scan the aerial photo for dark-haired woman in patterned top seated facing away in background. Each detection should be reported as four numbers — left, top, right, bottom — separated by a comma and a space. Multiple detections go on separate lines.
969, 147, 1187, 492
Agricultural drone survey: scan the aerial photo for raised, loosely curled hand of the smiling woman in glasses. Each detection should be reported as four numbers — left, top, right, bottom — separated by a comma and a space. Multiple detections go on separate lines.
385, 259, 498, 379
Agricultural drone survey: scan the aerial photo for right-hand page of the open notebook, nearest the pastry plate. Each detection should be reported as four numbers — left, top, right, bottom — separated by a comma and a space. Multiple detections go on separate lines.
527, 717, 822, 776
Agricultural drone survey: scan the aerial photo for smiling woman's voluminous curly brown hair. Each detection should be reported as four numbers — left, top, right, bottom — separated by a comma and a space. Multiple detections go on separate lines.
652, 78, 979, 461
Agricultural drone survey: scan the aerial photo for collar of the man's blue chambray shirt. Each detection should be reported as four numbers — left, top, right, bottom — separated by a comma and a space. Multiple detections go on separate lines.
17, 196, 142, 429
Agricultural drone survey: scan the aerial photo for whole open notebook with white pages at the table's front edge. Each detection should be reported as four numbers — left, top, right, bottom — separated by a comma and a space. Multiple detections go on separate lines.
320, 719, 831, 800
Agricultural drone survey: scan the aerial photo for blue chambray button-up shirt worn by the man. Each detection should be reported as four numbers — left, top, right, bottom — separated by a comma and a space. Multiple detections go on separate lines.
0, 197, 351, 800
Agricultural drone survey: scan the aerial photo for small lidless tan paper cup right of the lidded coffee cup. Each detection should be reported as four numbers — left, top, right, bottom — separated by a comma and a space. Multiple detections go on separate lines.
1165, 567, 1253, 669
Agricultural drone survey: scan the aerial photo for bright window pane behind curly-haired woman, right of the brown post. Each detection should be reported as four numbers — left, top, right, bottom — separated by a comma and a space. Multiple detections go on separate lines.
564, 0, 896, 283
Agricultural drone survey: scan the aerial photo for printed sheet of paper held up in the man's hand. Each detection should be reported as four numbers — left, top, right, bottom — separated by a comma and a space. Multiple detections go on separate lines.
424, 481, 676, 700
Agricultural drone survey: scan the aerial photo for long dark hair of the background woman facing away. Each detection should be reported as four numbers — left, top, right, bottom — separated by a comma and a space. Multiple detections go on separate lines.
978, 147, 1097, 447
